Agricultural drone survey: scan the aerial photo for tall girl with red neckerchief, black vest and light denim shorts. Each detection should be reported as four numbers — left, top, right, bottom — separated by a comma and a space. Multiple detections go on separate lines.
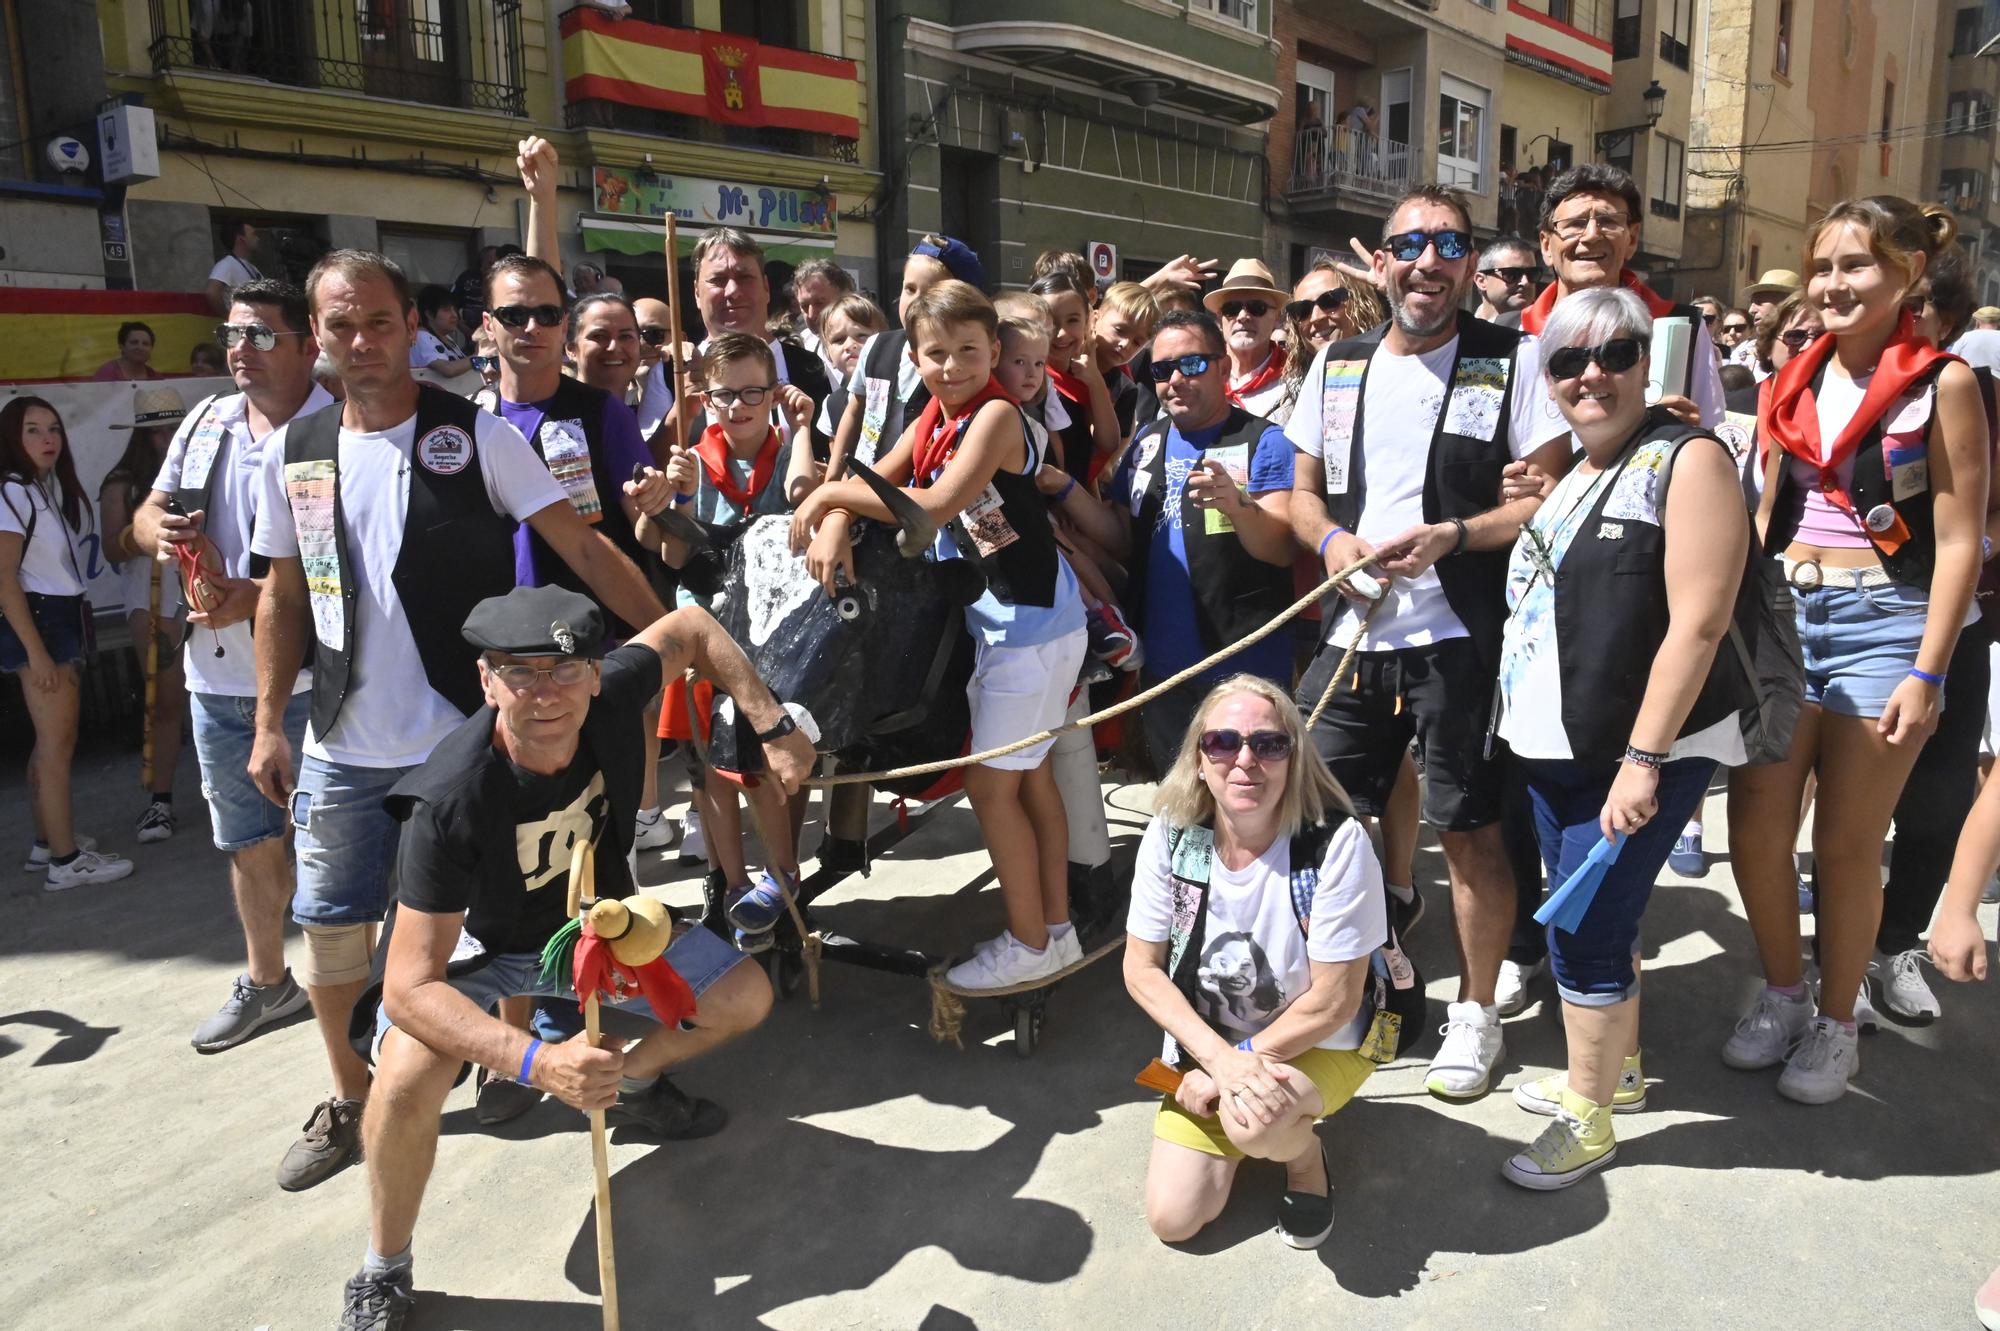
1722, 196, 1988, 1105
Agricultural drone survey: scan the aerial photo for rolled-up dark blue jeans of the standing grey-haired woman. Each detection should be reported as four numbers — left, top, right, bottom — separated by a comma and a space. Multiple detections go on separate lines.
1516, 757, 1716, 1007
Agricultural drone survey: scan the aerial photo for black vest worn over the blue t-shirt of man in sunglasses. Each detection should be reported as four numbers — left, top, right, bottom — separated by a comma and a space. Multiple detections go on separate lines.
1126, 408, 1292, 652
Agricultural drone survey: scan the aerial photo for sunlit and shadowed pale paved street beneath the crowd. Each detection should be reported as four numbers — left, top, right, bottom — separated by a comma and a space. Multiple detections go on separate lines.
0, 749, 2000, 1331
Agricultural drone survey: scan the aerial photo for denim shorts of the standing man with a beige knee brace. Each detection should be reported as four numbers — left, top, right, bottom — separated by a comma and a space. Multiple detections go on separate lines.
292, 753, 414, 925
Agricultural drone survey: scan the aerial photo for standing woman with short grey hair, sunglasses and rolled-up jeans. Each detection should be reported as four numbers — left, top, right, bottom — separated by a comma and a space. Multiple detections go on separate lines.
1498, 288, 1750, 1191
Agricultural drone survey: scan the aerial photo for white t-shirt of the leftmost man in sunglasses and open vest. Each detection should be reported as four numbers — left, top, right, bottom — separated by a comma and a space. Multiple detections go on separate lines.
152, 384, 334, 697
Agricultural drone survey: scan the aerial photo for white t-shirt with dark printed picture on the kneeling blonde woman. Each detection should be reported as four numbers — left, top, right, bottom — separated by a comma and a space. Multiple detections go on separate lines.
1126, 815, 1388, 1049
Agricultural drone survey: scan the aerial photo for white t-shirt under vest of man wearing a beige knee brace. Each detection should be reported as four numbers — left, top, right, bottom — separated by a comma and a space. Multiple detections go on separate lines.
250, 403, 568, 767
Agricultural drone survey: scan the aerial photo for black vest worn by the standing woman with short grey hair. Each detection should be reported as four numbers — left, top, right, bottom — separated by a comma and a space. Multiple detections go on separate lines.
1556, 408, 1756, 763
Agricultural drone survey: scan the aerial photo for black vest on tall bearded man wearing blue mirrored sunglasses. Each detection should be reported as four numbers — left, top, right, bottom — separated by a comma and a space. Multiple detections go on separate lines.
1322, 310, 1536, 669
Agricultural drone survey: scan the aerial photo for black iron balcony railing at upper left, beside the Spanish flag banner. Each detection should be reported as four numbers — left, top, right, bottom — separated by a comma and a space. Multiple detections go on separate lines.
148, 0, 528, 116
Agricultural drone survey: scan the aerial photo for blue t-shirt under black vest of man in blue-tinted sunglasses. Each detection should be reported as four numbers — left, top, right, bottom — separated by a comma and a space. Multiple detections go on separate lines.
1108, 415, 1292, 683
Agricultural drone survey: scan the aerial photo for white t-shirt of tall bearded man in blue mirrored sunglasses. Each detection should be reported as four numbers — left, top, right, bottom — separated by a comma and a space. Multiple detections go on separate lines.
1284, 338, 1570, 652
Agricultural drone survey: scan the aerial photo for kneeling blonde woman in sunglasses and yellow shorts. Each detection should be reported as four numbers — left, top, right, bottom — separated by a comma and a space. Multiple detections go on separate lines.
1124, 675, 1388, 1247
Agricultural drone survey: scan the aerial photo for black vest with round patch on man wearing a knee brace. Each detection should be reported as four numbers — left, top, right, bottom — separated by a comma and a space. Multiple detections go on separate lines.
284, 384, 514, 739
